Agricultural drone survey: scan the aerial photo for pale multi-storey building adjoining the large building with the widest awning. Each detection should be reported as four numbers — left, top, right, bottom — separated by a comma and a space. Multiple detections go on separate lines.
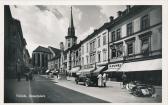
80, 23, 109, 74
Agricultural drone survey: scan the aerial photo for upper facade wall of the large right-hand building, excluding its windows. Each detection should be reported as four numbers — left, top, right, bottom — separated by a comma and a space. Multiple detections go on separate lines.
109, 6, 162, 62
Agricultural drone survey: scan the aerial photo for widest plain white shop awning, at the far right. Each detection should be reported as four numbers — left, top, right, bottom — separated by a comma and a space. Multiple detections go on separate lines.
119, 59, 162, 72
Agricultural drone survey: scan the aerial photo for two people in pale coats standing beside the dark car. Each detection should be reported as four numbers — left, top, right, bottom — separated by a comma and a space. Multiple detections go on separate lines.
97, 73, 107, 87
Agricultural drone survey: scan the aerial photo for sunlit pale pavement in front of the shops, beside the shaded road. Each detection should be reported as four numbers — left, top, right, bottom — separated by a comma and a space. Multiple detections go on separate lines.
44, 76, 162, 103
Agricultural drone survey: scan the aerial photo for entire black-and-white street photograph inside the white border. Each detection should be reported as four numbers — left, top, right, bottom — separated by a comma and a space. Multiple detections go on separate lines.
4, 5, 162, 103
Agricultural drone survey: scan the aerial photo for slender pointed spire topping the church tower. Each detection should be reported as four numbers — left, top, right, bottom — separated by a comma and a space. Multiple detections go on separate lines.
68, 6, 75, 36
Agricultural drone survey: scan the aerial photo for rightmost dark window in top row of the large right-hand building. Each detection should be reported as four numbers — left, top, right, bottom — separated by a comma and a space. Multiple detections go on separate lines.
141, 15, 149, 30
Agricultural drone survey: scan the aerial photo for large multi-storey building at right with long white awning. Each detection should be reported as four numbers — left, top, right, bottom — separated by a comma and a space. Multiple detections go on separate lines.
106, 5, 162, 84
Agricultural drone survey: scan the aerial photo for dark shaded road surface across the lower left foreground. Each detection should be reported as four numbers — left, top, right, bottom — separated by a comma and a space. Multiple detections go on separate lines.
4, 76, 108, 103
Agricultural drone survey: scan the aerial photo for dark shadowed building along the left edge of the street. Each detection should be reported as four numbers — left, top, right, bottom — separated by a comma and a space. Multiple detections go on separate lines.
4, 5, 26, 78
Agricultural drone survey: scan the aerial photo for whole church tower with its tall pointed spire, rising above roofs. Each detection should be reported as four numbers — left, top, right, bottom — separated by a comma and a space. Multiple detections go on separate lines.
65, 7, 77, 50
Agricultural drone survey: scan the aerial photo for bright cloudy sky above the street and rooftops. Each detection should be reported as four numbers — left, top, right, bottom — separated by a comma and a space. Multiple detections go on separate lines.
10, 5, 126, 55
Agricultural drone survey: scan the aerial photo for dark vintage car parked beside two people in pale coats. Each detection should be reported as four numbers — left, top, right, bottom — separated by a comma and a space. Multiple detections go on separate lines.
75, 74, 98, 86
